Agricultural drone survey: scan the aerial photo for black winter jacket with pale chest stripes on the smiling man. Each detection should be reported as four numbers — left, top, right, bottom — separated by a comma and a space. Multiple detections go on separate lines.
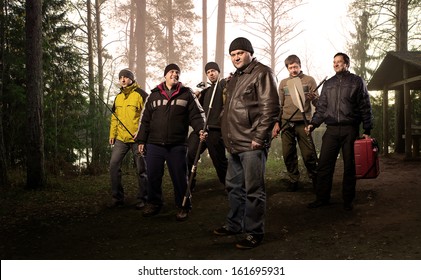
136, 83, 205, 145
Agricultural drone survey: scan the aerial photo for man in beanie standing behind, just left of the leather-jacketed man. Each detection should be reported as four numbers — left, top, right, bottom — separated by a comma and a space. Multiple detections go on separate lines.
187, 62, 228, 190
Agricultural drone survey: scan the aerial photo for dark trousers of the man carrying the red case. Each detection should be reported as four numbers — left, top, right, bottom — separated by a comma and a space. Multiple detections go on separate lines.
316, 125, 359, 202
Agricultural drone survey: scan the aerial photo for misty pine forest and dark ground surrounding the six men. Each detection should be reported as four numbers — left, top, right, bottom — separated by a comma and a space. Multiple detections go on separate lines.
0, 0, 421, 275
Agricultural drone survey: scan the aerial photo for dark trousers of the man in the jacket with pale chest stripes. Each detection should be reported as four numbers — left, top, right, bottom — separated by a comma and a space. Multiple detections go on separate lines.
146, 144, 191, 208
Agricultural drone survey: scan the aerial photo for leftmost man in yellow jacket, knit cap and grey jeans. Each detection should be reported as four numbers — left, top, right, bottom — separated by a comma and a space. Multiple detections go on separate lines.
109, 69, 148, 209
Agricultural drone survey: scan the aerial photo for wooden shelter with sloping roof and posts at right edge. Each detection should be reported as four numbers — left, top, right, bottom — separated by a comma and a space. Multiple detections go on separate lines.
368, 51, 421, 159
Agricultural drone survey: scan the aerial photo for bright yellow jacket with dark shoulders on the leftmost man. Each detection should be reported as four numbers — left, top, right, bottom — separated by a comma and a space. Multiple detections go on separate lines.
110, 82, 147, 143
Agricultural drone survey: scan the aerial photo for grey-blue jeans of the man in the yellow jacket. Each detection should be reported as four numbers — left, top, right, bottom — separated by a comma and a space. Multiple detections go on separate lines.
110, 140, 148, 201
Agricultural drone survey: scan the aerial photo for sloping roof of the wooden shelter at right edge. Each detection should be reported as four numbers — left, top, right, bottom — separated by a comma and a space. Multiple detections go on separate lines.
367, 51, 421, 90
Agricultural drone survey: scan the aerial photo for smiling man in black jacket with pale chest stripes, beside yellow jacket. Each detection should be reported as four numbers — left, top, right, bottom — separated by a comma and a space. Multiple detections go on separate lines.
136, 64, 205, 221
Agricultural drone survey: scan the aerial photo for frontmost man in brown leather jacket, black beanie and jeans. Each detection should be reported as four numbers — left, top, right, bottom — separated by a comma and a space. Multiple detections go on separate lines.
214, 37, 280, 249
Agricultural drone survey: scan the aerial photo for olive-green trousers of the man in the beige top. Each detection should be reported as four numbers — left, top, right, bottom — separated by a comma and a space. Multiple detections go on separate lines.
281, 122, 317, 182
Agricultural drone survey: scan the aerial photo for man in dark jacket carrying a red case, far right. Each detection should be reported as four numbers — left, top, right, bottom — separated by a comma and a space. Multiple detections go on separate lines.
306, 53, 373, 211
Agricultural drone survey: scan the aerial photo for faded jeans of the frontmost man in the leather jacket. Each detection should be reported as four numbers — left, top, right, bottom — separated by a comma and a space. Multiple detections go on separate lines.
225, 150, 267, 234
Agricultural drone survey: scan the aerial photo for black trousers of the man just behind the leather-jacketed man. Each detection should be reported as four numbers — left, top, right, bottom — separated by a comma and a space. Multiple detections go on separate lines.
187, 129, 228, 185
